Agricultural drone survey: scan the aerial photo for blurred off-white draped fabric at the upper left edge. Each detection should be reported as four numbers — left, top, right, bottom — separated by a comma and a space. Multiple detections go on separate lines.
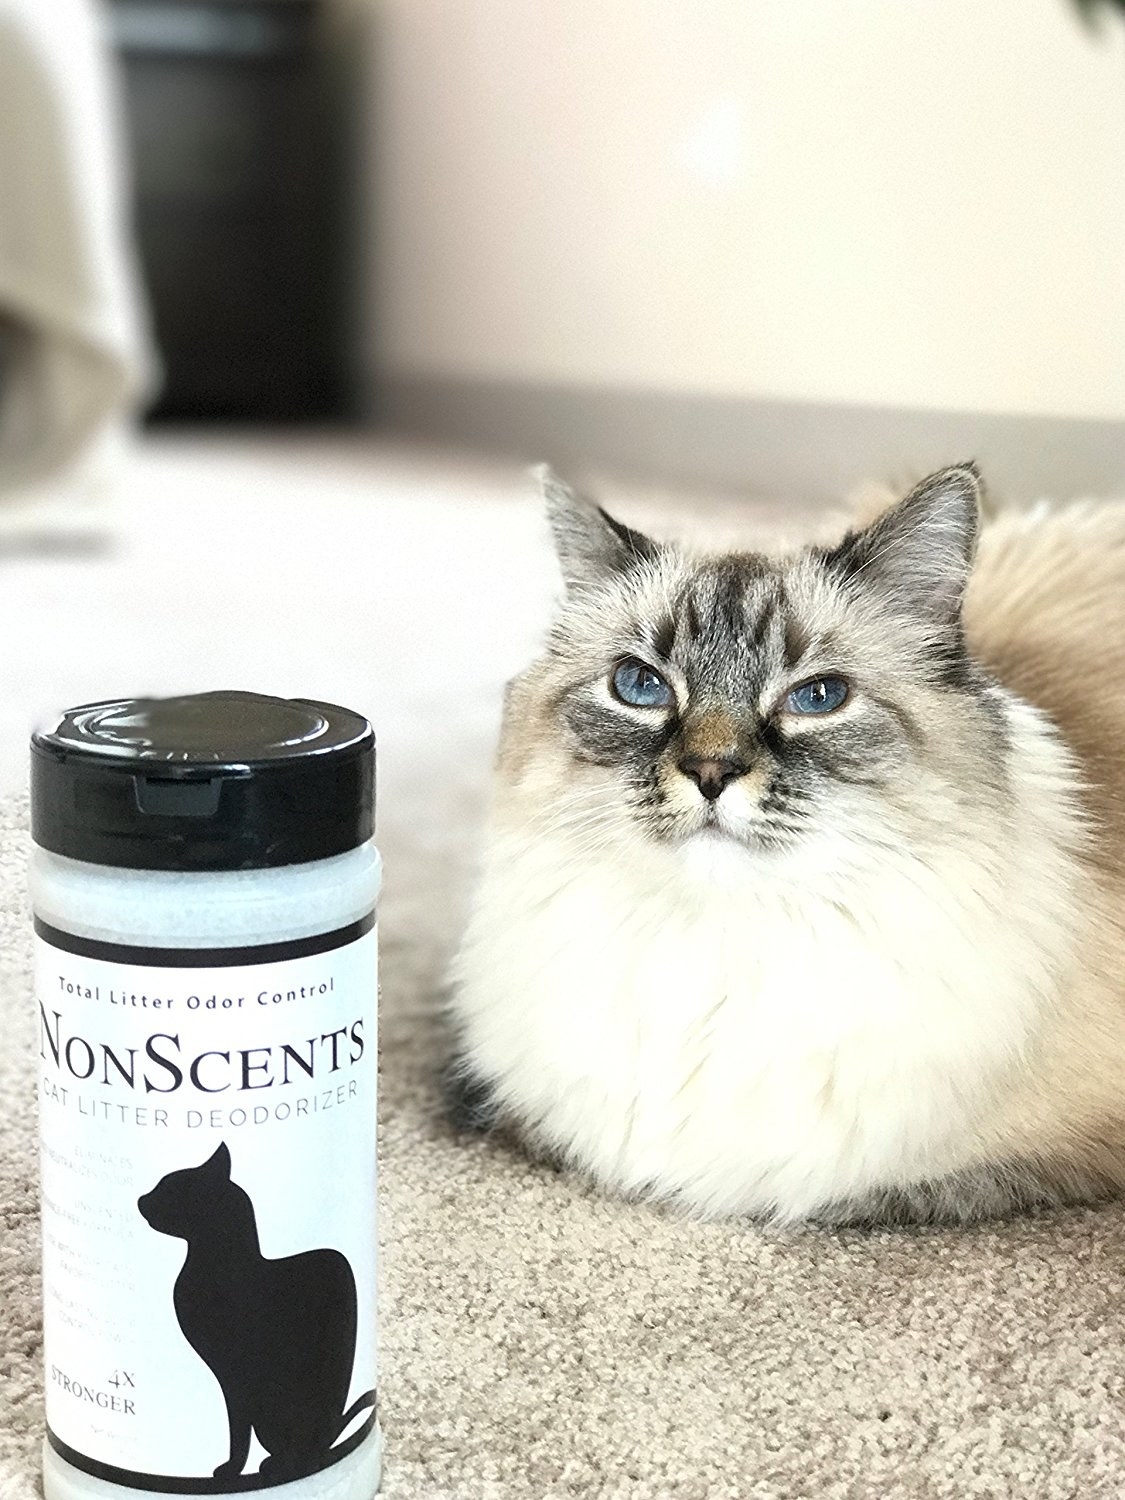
0, 0, 153, 513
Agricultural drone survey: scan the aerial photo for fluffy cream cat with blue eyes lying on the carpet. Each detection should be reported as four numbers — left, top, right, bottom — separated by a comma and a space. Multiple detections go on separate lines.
449, 464, 1125, 1226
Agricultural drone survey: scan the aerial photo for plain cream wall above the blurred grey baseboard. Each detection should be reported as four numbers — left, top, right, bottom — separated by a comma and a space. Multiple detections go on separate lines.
358, 0, 1125, 419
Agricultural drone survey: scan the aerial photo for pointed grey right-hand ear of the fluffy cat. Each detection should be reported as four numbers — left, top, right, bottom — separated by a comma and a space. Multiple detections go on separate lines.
827, 464, 984, 626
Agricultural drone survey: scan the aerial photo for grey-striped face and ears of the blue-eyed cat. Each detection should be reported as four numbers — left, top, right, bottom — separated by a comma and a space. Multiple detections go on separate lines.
506, 467, 998, 854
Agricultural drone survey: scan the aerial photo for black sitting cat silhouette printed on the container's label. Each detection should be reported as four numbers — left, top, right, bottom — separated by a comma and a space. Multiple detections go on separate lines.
137, 1145, 375, 1484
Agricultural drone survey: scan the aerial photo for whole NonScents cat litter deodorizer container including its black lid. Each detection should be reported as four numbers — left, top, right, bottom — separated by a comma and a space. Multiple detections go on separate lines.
32, 693, 381, 1500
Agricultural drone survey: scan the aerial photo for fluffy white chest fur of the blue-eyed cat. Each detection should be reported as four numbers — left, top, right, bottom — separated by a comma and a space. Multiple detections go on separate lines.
458, 839, 1061, 1220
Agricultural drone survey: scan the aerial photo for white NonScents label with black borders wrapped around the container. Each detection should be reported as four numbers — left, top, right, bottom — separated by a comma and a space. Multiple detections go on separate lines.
36, 920, 378, 1494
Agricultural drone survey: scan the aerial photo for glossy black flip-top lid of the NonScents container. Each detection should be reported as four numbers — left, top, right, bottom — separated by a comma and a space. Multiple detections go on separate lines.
32, 693, 375, 870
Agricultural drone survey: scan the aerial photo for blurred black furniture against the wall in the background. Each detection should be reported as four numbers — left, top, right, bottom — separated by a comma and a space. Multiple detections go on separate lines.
110, 0, 345, 422
